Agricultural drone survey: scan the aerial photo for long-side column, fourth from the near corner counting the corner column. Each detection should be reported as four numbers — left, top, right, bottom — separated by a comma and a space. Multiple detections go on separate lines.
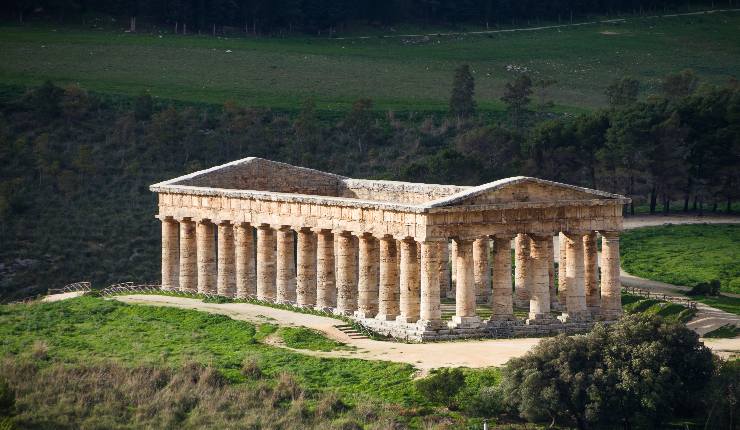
355, 233, 380, 318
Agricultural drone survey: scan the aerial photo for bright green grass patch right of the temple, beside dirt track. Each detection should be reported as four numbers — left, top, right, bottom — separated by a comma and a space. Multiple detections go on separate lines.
621, 225, 740, 292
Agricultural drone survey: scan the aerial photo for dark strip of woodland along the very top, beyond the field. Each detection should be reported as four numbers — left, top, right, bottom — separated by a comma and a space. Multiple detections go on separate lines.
0, 0, 737, 34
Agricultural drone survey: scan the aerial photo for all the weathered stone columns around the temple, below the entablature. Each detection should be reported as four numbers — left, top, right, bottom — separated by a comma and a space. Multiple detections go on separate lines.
162, 218, 621, 327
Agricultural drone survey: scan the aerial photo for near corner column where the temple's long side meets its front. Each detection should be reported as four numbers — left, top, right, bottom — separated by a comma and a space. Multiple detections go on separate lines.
419, 240, 447, 328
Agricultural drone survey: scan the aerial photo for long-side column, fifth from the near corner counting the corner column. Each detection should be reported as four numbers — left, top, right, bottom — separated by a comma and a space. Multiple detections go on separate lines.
334, 231, 357, 315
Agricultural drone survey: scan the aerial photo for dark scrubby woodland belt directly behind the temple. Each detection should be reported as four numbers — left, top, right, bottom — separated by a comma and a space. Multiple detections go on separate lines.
0, 66, 740, 298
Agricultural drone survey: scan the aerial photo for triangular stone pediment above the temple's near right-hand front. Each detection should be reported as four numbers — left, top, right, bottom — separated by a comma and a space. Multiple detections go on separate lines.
429, 176, 622, 207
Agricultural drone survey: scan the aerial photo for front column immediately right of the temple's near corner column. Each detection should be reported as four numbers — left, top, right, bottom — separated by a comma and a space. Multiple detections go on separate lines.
450, 239, 480, 328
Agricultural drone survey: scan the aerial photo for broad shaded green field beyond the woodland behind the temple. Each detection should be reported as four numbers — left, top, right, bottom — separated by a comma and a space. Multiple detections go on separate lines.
0, 13, 740, 111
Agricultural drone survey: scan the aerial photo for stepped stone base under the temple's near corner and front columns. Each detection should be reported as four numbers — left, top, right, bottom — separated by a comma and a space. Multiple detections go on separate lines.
352, 316, 596, 342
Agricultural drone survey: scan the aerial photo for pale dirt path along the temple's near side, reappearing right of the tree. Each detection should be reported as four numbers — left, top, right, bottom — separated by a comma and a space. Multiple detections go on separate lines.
114, 294, 740, 373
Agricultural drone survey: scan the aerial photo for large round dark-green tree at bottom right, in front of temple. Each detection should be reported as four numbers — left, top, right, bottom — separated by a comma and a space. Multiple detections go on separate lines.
501, 314, 713, 429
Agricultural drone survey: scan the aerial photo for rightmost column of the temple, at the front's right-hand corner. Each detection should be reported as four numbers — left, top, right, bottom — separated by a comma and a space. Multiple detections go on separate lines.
601, 231, 622, 320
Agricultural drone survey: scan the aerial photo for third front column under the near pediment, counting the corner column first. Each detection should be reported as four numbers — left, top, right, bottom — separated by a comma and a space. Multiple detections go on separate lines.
491, 235, 514, 320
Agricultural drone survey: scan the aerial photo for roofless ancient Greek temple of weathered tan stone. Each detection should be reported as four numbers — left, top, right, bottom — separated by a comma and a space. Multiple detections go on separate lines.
150, 158, 629, 341
